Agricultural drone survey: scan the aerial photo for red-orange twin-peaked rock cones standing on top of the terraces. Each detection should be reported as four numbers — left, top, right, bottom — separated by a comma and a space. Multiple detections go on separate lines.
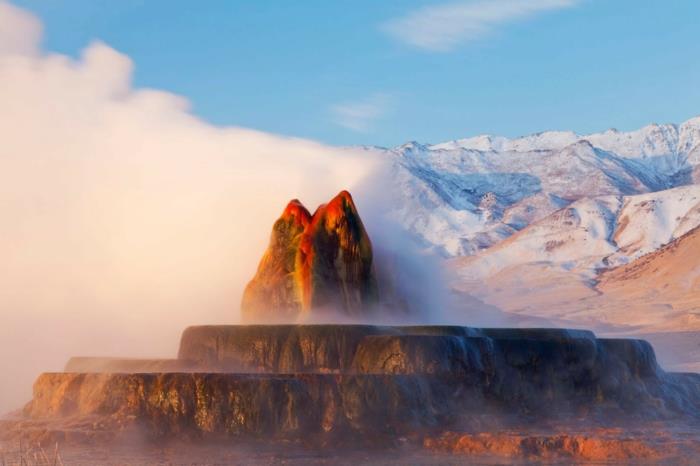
241, 191, 378, 322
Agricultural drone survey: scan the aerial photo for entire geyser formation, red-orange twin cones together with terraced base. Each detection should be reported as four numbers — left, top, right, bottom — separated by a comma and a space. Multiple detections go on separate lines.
0, 191, 700, 460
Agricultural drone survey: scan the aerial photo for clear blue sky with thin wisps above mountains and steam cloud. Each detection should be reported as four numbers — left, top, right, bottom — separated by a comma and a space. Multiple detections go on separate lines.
13, 0, 700, 146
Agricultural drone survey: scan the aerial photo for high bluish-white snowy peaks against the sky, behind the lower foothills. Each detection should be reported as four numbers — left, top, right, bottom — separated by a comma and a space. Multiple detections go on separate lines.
383, 117, 700, 257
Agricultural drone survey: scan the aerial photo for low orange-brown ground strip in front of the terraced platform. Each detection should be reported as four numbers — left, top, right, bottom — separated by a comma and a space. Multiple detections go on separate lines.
0, 425, 700, 466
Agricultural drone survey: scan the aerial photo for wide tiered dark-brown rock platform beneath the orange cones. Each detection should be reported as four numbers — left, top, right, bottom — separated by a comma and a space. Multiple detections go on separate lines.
0, 325, 700, 458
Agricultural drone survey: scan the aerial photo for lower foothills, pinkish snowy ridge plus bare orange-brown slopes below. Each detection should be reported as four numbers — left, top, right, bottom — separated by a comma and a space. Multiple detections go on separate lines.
442, 185, 700, 344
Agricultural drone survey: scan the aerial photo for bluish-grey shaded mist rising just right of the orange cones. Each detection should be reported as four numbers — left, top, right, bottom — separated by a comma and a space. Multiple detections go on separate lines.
355, 166, 510, 327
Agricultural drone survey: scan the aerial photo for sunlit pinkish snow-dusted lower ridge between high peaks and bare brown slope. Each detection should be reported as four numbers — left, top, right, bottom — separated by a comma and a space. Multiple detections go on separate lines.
455, 185, 700, 280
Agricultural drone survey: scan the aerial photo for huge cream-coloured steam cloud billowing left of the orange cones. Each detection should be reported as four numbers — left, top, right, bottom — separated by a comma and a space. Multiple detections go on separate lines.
0, 3, 374, 414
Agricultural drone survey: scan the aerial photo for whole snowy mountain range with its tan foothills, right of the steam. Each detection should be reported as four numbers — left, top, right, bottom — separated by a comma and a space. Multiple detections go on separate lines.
368, 117, 700, 362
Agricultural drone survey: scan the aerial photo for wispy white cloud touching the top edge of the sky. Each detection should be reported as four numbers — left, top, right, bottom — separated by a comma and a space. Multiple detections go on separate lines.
383, 0, 580, 52
